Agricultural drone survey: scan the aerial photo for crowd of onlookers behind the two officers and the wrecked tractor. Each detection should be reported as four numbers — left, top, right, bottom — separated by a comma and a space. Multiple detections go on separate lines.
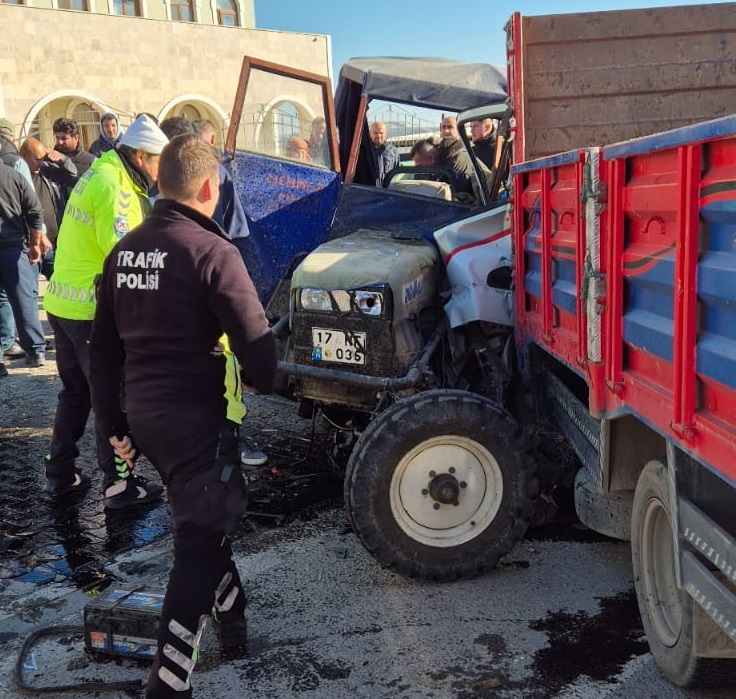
0, 112, 497, 377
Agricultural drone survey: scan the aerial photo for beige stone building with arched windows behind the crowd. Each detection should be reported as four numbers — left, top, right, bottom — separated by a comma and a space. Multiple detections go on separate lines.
0, 0, 331, 146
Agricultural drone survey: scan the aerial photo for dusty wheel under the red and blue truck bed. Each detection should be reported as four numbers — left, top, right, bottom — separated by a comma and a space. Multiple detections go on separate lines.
631, 461, 736, 687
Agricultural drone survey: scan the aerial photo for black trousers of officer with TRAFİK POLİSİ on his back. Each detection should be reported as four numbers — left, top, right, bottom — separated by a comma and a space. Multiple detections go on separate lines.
128, 406, 247, 699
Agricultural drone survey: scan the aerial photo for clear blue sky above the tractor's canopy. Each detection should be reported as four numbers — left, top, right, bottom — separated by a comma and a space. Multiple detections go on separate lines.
255, 0, 717, 80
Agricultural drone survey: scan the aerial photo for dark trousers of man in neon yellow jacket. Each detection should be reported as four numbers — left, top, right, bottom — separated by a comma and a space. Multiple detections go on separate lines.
46, 313, 118, 488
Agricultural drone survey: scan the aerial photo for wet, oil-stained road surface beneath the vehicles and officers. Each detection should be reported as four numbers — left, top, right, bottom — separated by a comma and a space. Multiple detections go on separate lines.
0, 288, 736, 699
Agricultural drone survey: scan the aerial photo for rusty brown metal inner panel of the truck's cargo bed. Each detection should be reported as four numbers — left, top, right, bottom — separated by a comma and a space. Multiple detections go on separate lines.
521, 3, 736, 160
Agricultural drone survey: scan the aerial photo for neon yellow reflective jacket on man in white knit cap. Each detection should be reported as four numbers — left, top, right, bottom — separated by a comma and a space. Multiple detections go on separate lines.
43, 150, 151, 320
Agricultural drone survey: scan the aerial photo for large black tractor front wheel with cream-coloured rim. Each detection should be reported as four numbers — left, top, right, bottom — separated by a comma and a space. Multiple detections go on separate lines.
345, 390, 537, 581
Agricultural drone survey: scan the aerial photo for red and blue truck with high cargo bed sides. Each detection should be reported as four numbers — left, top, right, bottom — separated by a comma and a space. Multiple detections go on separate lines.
509, 4, 736, 685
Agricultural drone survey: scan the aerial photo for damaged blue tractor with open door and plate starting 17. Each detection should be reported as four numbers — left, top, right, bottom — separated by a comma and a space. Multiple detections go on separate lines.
228, 59, 538, 580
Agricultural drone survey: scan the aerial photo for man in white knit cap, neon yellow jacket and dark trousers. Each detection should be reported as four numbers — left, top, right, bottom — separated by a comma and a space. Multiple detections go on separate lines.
44, 115, 168, 509
